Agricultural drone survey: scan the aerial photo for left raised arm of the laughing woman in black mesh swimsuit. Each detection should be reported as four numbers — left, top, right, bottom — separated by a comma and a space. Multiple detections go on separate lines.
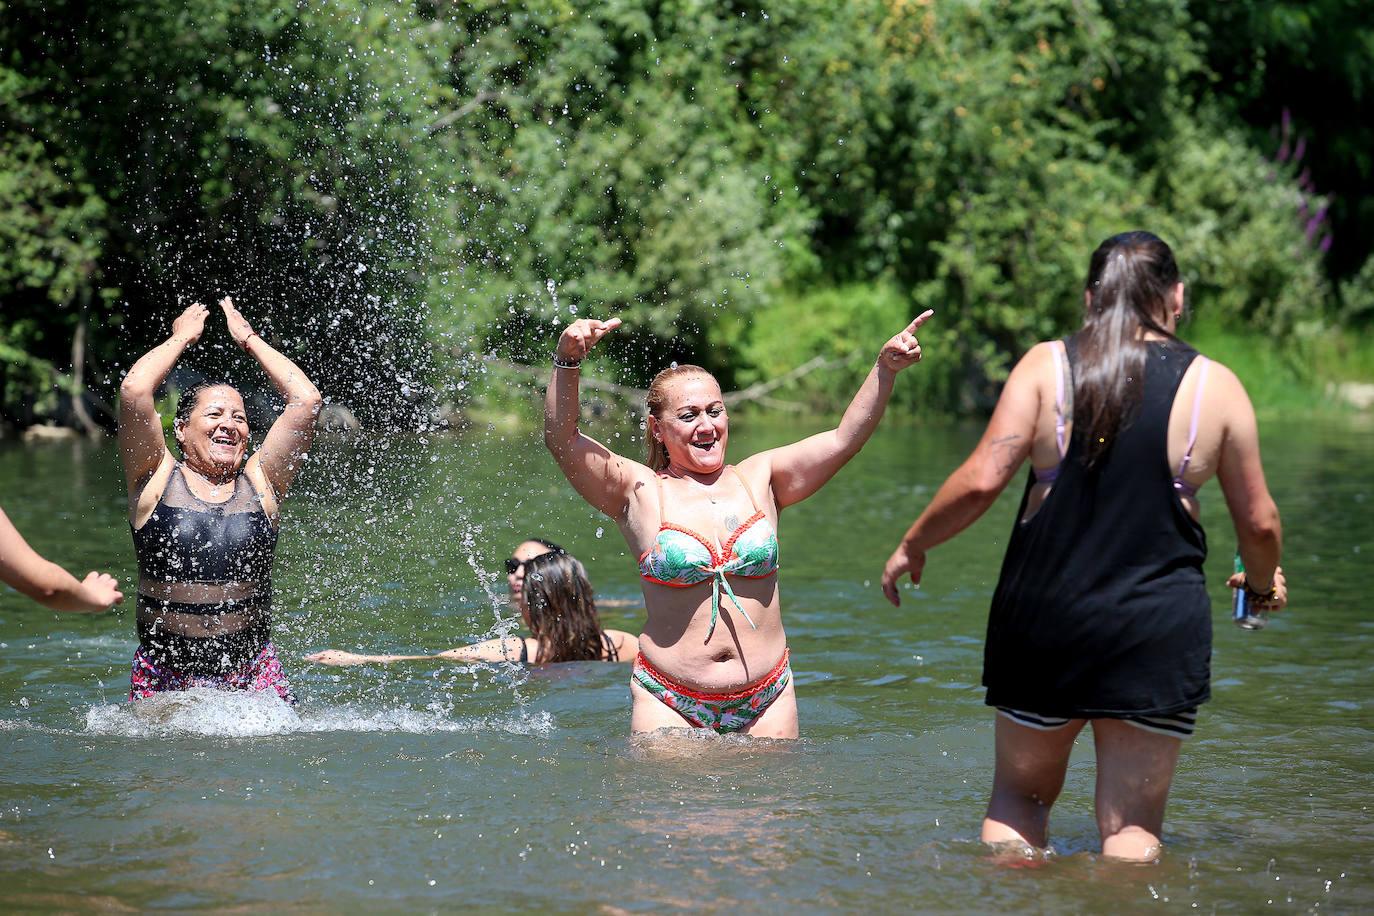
120, 302, 210, 500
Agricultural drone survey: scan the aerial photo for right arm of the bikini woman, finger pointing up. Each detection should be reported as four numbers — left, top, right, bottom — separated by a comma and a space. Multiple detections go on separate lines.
750, 309, 934, 508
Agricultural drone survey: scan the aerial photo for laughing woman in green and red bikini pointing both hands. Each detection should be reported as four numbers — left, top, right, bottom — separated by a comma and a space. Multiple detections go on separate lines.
544, 312, 932, 737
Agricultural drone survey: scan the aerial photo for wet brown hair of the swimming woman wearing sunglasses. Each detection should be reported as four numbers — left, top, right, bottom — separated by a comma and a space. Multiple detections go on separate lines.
525, 551, 605, 665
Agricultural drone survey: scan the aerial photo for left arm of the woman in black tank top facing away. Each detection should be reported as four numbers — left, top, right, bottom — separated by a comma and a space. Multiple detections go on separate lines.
882, 352, 1040, 607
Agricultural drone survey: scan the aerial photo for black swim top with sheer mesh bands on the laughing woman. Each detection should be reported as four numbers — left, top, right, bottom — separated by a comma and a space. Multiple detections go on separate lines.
131, 461, 276, 676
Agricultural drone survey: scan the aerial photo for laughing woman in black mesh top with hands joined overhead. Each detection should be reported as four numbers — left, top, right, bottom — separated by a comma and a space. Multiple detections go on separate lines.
120, 297, 320, 700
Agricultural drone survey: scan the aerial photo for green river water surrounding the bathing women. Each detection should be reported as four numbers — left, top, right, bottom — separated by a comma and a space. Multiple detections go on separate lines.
0, 417, 1374, 913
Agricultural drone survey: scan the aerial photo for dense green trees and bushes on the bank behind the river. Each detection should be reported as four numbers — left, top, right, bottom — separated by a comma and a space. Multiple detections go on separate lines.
0, 0, 1374, 423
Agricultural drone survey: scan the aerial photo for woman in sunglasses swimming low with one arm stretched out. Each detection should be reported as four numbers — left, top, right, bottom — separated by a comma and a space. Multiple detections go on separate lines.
305, 538, 639, 665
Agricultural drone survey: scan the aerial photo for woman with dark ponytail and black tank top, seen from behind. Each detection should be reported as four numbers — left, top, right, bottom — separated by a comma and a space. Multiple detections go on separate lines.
882, 232, 1287, 860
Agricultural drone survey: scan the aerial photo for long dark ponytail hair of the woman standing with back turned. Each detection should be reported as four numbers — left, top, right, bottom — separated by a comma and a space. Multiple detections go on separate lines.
1073, 231, 1179, 467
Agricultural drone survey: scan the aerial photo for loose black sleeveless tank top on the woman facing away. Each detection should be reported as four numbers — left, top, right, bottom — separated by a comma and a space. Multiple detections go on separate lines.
982, 339, 1212, 718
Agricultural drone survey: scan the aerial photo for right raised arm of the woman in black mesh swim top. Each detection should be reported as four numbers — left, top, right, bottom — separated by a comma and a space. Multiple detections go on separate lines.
220, 297, 322, 499
